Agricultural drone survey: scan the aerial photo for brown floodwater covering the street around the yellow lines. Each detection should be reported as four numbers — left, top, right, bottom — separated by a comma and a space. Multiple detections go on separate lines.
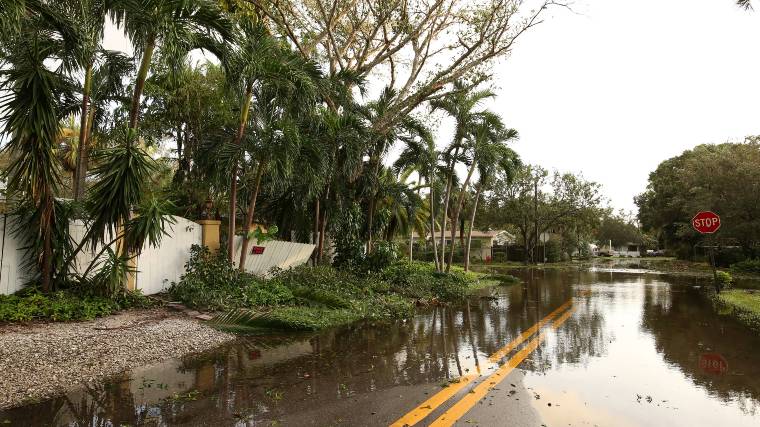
0, 270, 760, 427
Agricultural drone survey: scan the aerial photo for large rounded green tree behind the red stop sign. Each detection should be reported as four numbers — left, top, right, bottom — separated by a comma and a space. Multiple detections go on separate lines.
636, 137, 760, 256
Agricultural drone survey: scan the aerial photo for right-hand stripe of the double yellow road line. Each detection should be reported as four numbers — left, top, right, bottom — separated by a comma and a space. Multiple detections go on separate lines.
430, 308, 575, 427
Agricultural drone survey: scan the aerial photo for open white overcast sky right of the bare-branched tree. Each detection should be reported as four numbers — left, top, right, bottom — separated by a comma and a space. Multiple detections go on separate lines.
492, 0, 760, 210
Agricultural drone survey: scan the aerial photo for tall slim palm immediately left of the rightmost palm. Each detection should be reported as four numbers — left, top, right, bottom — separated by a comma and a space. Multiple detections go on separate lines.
430, 81, 495, 271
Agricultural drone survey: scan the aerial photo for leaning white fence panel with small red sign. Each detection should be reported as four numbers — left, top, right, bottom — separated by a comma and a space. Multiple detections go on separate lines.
234, 236, 316, 275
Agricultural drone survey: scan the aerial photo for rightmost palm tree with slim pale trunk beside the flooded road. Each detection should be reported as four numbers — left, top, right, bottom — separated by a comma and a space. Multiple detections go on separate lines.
464, 121, 520, 271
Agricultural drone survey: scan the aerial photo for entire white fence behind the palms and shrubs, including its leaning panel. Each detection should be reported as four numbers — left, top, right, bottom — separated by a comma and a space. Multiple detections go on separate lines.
0, 215, 314, 295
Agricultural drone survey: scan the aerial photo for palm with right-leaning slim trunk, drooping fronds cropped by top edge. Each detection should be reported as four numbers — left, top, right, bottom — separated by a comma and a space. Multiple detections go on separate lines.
109, 0, 232, 129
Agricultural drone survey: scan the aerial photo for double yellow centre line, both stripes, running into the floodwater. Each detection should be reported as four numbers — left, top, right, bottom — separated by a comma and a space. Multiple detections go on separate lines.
391, 300, 575, 427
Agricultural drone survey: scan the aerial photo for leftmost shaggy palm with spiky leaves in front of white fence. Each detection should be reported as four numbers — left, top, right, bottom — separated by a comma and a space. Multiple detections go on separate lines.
0, 2, 76, 291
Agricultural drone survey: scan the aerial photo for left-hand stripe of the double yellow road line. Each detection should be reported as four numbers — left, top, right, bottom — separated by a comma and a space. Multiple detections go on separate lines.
390, 299, 573, 427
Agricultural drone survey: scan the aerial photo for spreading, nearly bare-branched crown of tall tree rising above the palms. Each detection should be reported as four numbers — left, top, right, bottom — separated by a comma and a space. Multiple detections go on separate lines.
247, 0, 561, 137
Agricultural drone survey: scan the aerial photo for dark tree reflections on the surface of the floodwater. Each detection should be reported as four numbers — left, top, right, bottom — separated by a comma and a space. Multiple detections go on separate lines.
0, 270, 760, 426
